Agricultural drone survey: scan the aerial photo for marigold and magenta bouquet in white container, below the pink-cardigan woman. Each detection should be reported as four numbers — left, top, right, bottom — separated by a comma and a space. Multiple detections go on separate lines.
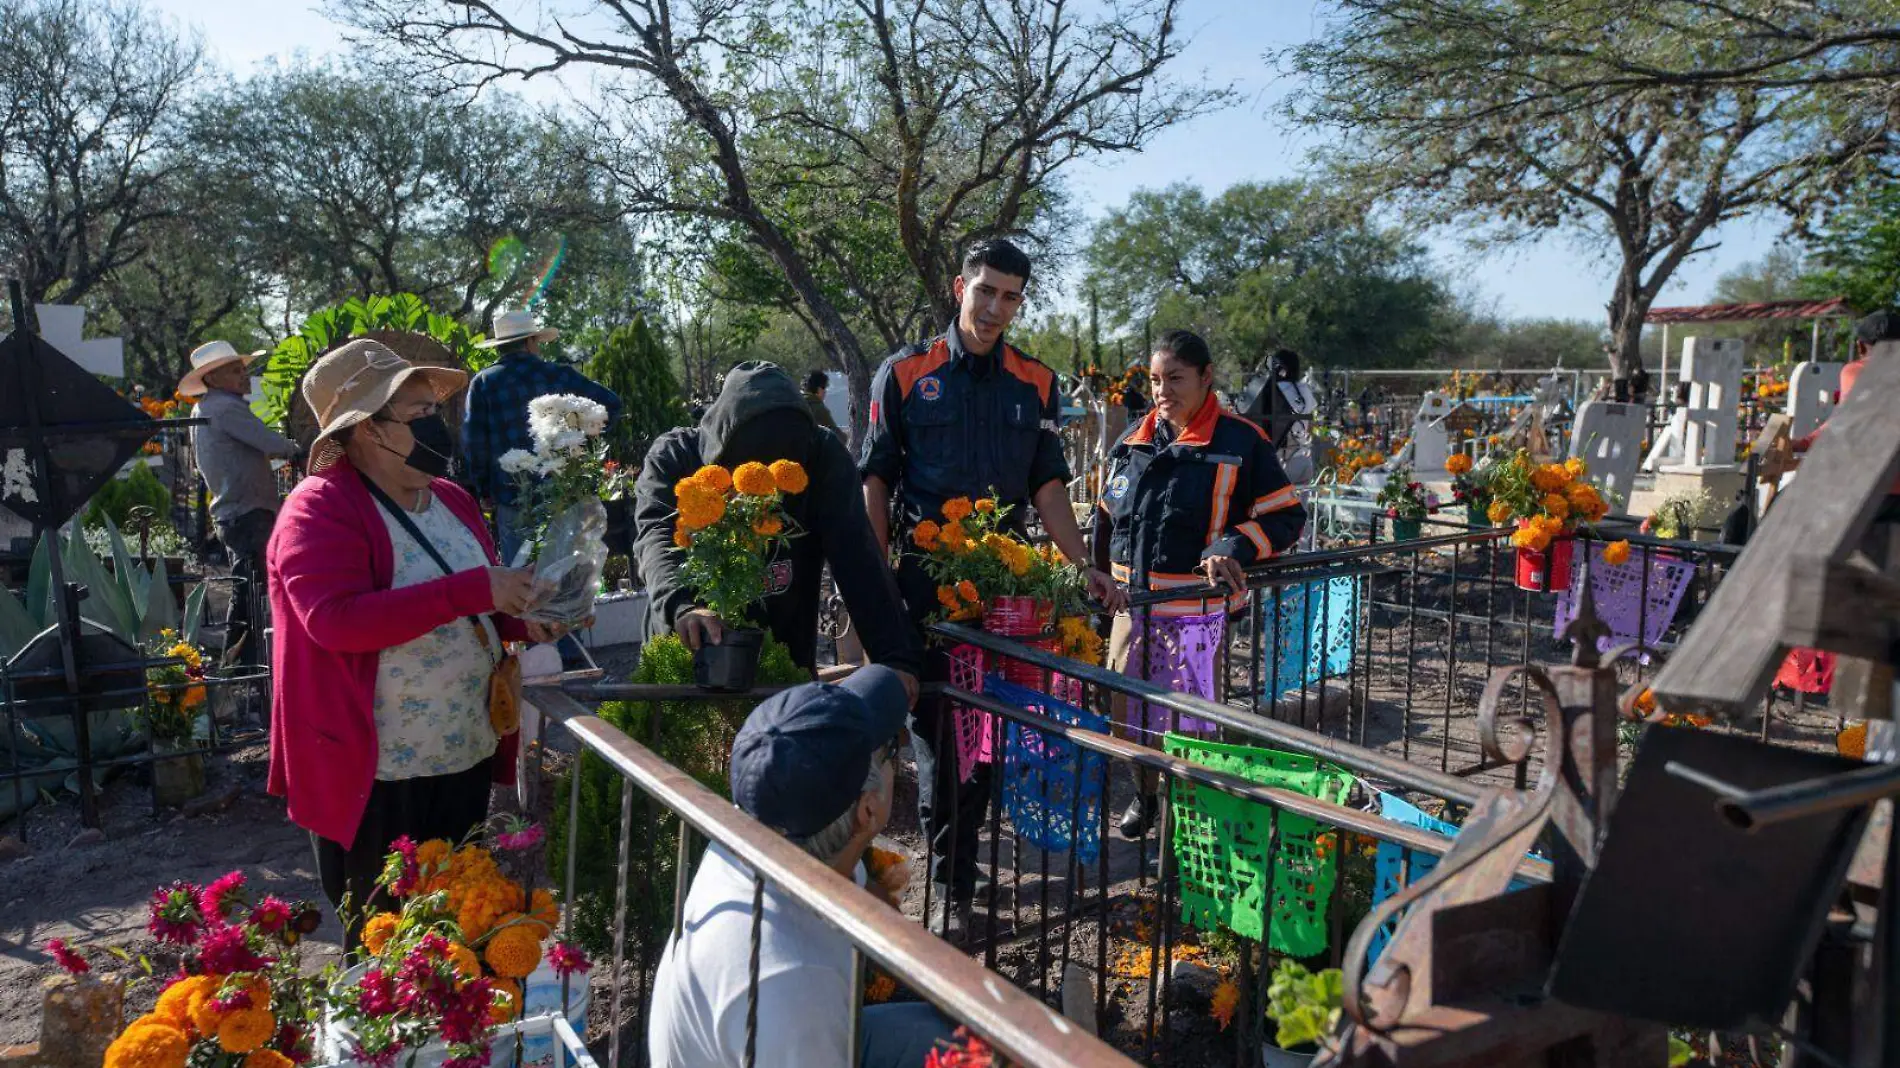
321, 821, 589, 1068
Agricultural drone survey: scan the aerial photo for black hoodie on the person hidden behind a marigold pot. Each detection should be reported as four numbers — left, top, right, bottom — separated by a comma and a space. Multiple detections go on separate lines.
633, 361, 923, 675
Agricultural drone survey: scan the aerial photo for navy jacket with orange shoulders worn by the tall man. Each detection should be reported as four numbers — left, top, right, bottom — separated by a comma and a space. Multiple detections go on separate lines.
857, 327, 1070, 528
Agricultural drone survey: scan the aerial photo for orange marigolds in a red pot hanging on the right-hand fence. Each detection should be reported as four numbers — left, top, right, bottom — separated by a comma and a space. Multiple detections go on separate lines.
1490, 450, 1609, 591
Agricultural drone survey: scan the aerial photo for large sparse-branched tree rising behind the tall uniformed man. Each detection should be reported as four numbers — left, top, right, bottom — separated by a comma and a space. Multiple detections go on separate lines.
338, 0, 1224, 437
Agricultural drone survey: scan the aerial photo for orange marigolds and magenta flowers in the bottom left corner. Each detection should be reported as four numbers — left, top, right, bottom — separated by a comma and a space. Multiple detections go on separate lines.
97, 872, 321, 1068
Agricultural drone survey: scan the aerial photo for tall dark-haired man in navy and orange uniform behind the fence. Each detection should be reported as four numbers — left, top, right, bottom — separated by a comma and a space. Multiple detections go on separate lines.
859, 239, 1123, 933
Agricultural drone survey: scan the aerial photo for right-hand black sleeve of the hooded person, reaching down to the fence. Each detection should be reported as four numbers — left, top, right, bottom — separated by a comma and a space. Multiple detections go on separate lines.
808, 433, 923, 675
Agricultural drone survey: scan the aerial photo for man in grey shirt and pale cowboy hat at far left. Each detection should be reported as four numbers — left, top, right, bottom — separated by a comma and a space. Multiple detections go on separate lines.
179, 342, 296, 663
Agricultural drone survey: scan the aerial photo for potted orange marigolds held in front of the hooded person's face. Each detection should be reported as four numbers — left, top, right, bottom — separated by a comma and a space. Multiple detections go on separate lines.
673, 460, 809, 692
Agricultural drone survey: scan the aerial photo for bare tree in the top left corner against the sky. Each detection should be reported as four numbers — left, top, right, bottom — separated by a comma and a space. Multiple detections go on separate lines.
0, 0, 201, 302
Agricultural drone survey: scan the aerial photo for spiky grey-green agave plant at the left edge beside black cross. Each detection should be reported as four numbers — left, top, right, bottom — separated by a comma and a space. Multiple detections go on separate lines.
0, 519, 205, 659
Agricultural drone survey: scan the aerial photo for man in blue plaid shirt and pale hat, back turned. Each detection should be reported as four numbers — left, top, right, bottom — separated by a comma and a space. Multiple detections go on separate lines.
462, 308, 619, 564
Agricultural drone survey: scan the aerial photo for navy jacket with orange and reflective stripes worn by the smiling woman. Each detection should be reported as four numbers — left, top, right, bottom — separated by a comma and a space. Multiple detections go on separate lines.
1098, 397, 1305, 604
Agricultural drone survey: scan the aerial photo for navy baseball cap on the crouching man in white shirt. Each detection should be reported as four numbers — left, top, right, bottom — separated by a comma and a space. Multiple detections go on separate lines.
730, 665, 910, 838
